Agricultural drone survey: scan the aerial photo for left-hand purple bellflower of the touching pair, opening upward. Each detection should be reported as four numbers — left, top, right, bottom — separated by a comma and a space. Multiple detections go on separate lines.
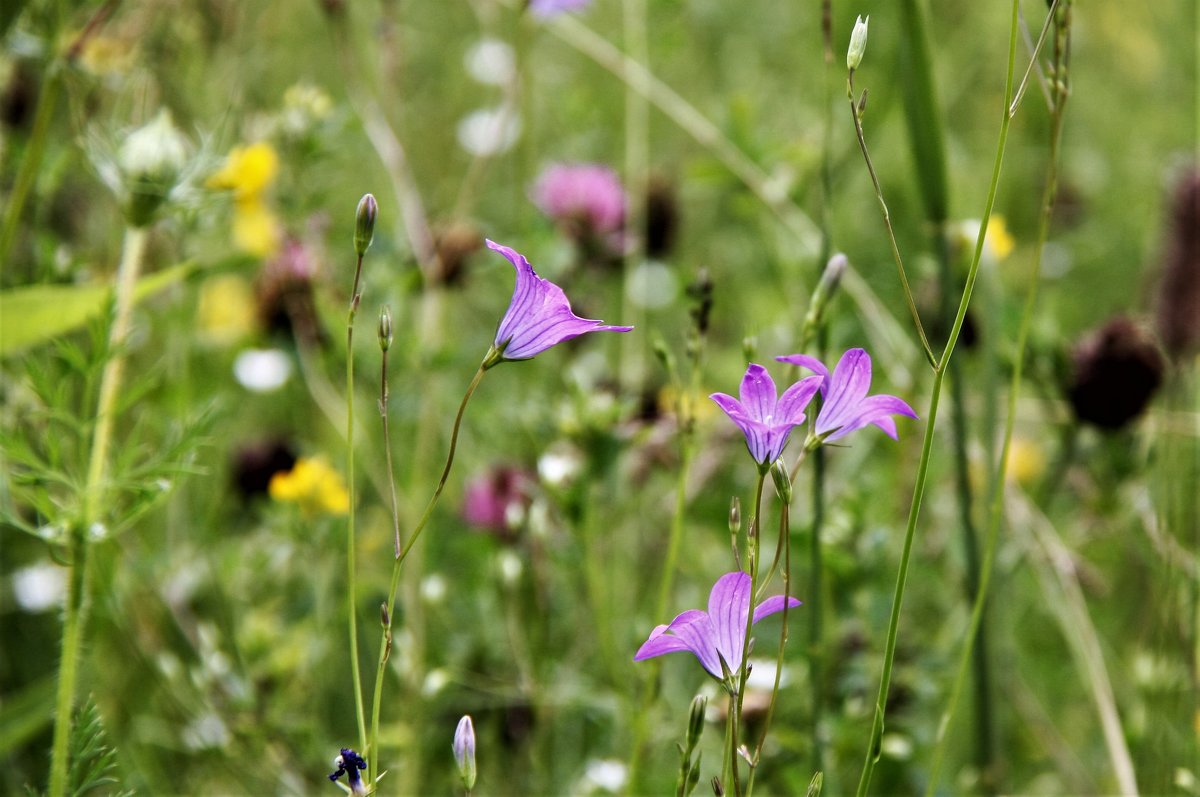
709, 362, 821, 468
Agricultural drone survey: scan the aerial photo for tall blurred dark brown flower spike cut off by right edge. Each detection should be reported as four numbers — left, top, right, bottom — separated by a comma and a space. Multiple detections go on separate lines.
1158, 170, 1200, 358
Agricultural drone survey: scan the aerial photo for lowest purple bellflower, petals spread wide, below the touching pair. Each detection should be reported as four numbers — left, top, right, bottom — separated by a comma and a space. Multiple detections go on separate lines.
634, 570, 800, 681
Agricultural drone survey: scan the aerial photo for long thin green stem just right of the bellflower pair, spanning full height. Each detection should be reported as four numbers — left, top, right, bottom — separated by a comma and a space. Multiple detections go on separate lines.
857, 7, 1020, 797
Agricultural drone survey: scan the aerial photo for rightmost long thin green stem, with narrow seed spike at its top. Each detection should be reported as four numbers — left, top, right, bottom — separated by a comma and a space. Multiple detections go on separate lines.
925, 2, 1070, 797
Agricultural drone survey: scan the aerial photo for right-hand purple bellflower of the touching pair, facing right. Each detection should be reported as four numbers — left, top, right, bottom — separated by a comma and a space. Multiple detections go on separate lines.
775, 349, 917, 443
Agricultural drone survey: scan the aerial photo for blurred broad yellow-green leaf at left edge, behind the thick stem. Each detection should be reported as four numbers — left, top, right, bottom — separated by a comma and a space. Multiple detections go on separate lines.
0, 262, 198, 356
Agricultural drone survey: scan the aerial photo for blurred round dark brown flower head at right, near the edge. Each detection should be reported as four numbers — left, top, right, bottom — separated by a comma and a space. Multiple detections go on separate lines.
1067, 316, 1164, 431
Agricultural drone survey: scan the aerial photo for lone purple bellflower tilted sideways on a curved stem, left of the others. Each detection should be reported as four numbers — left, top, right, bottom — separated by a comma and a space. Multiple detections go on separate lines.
485, 241, 634, 367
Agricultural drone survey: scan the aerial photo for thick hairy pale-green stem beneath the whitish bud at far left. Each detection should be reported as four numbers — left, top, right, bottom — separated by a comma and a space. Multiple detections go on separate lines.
49, 227, 146, 797
